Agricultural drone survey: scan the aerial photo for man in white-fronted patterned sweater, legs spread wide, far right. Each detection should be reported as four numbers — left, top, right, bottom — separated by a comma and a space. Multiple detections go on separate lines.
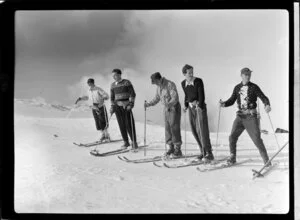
220, 68, 271, 166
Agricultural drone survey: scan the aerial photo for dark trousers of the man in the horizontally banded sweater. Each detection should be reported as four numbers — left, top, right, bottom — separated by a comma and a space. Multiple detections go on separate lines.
115, 105, 136, 143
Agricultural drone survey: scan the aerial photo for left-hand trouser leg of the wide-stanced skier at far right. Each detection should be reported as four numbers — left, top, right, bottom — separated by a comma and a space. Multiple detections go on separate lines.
229, 116, 245, 157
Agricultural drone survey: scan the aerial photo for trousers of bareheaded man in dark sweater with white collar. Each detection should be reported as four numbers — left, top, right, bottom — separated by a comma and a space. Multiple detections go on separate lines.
189, 106, 212, 156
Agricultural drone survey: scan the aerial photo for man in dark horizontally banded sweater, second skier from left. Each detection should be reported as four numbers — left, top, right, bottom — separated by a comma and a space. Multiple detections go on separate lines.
110, 69, 138, 151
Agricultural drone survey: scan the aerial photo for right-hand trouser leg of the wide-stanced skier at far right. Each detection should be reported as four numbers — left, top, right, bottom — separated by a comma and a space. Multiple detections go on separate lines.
243, 115, 269, 163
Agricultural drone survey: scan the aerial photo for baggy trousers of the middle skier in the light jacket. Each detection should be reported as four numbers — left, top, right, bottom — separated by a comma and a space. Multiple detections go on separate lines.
164, 102, 182, 147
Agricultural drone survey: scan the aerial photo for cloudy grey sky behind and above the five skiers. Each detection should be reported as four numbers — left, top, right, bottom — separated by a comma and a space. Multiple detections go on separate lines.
15, 10, 289, 132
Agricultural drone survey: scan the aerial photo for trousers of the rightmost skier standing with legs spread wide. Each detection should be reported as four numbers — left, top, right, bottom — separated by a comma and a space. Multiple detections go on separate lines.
229, 114, 269, 163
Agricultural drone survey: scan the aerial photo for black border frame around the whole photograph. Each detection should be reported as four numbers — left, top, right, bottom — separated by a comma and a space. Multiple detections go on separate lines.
0, 0, 295, 220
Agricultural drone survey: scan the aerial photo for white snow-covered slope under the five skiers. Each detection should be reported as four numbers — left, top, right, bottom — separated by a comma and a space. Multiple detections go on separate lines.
15, 100, 289, 213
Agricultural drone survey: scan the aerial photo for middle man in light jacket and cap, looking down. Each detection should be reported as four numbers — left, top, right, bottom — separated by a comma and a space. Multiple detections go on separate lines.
144, 72, 182, 158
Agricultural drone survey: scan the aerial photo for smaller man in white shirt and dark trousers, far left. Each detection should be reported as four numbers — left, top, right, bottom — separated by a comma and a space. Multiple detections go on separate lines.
75, 78, 110, 142
